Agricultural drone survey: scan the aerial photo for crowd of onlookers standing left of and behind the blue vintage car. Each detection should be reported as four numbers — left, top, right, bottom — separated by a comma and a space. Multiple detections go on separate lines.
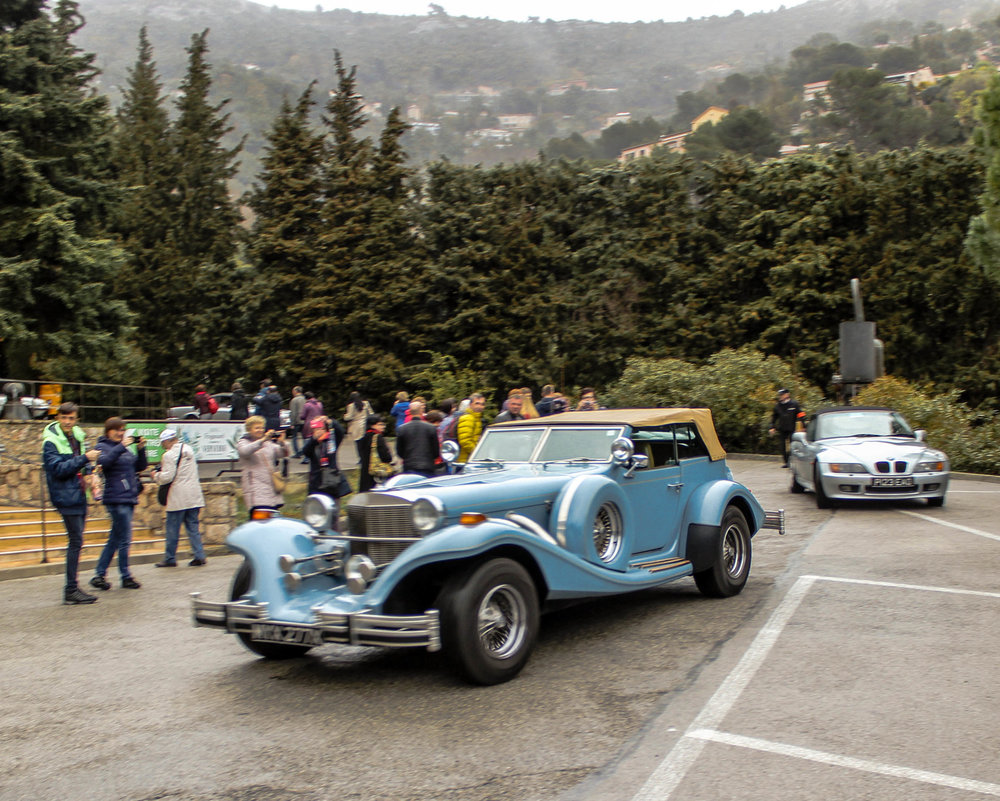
42, 379, 599, 604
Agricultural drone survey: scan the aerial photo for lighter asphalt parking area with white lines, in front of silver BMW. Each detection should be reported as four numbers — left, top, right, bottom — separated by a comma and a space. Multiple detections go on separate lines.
570, 468, 1000, 801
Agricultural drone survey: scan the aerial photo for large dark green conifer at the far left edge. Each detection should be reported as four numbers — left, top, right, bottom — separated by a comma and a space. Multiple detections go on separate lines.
0, 0, 141, 382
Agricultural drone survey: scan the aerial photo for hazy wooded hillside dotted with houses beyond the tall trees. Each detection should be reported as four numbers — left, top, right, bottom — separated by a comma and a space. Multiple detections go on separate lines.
76, 0, 1000, 188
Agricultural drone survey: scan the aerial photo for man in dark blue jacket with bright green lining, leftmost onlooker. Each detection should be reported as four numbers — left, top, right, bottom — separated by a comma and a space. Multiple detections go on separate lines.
42, 403, 100, 604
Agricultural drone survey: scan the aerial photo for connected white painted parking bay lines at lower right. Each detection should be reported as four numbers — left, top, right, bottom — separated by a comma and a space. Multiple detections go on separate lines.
632, 576, 1000, 801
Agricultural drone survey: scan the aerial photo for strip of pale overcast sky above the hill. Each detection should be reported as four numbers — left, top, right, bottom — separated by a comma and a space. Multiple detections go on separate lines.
255, 0, 804, 22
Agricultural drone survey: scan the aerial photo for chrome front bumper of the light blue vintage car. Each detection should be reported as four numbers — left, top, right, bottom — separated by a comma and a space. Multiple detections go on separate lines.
191, 592, 441, 651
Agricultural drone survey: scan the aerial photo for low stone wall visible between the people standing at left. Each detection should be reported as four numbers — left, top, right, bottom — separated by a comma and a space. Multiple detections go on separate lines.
0, 420, 238, 545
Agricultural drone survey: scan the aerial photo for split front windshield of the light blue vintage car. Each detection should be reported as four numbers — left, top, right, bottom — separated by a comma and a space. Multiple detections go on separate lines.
469, 426, 623, 463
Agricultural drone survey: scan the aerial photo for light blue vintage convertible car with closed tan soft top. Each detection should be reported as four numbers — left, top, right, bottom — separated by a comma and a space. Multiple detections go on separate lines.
193, 409, 784, 684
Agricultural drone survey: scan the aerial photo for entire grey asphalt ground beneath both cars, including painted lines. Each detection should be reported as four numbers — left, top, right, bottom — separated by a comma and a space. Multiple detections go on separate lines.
0, 459, 1000, 801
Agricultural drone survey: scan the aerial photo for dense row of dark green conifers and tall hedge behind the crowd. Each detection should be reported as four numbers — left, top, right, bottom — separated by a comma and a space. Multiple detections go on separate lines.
0, 0, 1000, 432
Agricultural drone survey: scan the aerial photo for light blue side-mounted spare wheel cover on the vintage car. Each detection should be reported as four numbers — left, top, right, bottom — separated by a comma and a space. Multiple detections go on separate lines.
549, 475, 634, 570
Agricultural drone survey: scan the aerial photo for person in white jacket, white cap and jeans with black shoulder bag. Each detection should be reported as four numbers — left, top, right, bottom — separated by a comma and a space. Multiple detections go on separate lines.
153, 428, 205, 567
